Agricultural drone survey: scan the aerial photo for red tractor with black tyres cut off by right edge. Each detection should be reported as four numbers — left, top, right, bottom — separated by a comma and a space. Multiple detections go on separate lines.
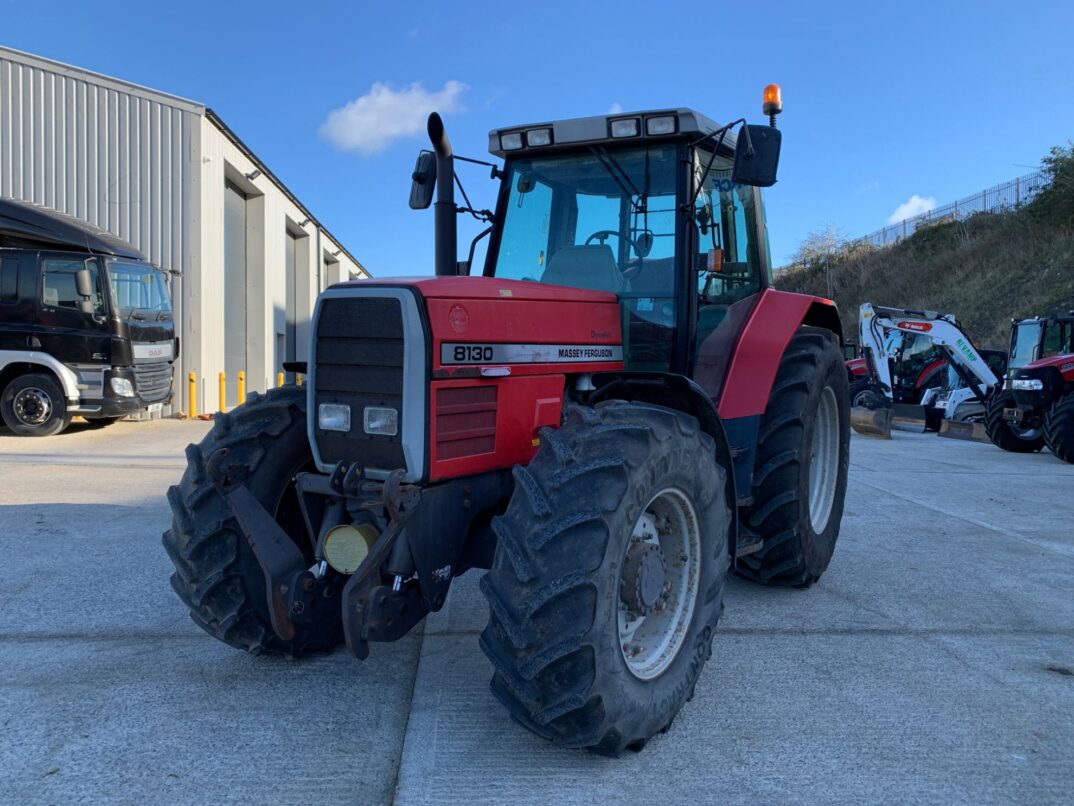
985, 311, 1074, 463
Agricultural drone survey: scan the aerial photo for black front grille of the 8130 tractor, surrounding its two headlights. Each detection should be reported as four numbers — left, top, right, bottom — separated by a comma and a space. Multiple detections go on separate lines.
310, 297, 407, 471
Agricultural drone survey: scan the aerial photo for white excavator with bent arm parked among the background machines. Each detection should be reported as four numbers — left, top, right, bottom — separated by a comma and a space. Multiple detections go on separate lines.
851, 302, 1000, 436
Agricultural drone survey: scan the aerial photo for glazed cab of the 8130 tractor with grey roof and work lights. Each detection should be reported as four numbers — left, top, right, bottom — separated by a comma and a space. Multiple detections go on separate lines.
483, 110, 780, 375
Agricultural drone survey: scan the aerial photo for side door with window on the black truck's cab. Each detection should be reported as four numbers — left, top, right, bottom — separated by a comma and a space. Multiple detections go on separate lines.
34, 253, 111, 364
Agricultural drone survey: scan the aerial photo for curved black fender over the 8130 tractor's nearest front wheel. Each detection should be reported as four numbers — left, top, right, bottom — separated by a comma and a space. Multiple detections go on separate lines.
586, 371, 739, 558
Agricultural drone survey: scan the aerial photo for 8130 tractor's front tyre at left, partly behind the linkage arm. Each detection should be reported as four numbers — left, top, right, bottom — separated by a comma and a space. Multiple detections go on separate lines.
163, 386, 343, 657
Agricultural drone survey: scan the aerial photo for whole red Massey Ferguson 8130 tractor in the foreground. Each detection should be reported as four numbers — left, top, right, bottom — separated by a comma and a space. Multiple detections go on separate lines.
163, 85, 850, 755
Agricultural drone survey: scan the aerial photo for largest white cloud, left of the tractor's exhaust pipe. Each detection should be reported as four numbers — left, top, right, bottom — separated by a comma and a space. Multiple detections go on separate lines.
320, 81, 467, 154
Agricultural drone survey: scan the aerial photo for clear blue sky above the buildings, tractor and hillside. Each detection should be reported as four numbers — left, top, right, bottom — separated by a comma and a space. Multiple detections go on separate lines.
0, 0, 1074, 276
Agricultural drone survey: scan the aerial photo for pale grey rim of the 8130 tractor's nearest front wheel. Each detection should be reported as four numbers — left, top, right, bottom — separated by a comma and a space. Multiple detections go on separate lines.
619, 487, 701, 680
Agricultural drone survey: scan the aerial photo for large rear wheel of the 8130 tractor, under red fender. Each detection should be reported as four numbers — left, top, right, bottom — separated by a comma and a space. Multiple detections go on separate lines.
737, 327, 846, 588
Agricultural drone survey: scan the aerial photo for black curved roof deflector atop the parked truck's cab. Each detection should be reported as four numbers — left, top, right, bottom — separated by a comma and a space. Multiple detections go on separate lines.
0, 198, 145, 261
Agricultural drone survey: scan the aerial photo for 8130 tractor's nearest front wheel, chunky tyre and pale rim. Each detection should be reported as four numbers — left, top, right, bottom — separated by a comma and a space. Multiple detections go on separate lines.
481, 401, 731, 755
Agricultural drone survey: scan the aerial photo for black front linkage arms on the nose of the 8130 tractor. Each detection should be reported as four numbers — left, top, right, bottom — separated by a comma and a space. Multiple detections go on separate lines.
206, 448, 509, 660
